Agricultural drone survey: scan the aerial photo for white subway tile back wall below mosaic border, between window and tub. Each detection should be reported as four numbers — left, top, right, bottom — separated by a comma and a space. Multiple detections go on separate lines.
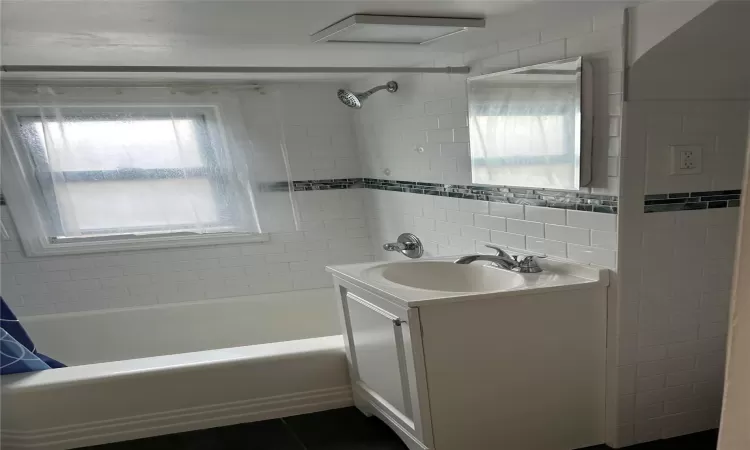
0, 189, 373, 316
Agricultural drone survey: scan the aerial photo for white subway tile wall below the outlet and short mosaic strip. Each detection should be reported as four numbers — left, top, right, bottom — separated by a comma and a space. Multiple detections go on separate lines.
619, 208, 738, 442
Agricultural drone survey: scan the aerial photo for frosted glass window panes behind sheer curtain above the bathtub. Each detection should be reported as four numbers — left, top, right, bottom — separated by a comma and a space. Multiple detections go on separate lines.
12, 108, 257, 237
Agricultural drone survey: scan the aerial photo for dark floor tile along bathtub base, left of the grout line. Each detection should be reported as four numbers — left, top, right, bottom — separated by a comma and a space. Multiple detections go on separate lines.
81, 420, 305, 450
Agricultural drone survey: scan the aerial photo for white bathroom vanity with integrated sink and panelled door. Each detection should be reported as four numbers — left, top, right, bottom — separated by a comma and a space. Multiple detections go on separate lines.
328, 258, 609, 450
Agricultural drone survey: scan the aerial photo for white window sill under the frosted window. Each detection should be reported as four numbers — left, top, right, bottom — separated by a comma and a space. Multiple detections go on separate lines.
24, 233, 269, 256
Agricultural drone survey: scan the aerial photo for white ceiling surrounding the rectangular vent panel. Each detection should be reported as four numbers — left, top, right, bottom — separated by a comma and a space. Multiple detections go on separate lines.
0, 0, 636, 80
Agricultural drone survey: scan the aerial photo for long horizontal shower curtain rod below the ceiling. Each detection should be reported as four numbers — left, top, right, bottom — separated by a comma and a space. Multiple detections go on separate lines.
2, 65, 471, 73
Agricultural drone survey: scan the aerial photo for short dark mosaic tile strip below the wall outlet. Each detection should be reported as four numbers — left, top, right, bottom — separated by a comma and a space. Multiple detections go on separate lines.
643, 189, 742, 213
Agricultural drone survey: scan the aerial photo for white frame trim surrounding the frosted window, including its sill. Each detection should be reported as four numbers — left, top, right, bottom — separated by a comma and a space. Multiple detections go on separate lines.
0, 89, 270, 256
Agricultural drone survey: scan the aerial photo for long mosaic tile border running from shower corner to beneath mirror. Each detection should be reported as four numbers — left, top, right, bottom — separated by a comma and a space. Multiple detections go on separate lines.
261, 178, 617, 214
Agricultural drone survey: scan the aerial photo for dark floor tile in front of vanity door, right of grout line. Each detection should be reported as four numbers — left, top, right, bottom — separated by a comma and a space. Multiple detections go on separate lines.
284, 408, 407, 450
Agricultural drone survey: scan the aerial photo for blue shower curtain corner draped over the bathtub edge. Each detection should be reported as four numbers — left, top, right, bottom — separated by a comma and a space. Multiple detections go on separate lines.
0, 297, 65, 375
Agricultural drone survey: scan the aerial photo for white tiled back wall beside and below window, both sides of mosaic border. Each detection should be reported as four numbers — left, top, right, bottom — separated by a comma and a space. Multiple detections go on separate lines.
0, 83, 372, 316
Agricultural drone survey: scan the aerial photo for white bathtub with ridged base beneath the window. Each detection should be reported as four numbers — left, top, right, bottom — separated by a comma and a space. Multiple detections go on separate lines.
1, 289, 353, 450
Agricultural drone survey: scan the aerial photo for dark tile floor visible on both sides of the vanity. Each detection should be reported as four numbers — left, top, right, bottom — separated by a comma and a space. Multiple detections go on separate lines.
81, 408, 717, 450
